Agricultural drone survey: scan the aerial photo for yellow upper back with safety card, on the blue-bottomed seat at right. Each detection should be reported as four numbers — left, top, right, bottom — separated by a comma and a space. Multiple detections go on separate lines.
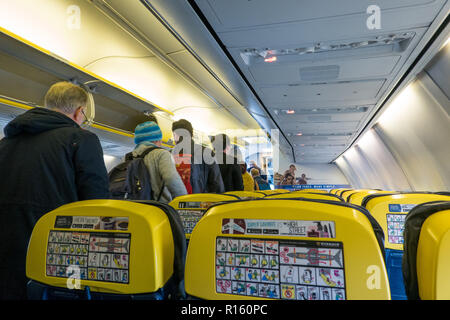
362, 192, 450, 250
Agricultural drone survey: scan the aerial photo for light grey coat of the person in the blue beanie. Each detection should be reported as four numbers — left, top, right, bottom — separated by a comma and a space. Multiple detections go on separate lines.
133, 142, 187, 203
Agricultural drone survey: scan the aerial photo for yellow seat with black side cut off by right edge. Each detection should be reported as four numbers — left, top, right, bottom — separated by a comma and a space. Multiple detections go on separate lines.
403, 201, 450, 300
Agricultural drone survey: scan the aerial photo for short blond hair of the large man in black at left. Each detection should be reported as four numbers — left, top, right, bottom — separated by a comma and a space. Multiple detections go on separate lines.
44, 81, 88, 114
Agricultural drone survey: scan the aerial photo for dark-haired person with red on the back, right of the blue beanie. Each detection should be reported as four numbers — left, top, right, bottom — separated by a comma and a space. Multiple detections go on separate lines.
172, 119, 225, 193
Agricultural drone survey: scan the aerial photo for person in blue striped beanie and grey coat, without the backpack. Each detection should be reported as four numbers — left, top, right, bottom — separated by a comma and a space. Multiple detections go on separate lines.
133, 121, 187, 203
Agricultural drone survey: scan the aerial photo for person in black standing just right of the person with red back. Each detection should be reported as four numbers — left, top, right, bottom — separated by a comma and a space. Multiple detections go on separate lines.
211, 133, 244, 192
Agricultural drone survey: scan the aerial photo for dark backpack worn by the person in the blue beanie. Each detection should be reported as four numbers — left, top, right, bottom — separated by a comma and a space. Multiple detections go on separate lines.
108, 147, 164, 201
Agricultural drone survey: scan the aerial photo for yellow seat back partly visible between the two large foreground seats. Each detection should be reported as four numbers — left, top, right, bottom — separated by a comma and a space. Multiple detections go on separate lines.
169, 193, 239, 239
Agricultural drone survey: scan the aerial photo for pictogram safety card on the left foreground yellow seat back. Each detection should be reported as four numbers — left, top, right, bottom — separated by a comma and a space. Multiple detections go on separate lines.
46, 231, 131, 284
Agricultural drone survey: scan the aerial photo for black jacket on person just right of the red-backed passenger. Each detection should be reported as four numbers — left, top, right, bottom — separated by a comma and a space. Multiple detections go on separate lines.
216, 153, 244, 192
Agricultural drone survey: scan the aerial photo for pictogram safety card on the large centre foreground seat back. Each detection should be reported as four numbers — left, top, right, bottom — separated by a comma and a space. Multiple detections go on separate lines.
215, 237, 346, 300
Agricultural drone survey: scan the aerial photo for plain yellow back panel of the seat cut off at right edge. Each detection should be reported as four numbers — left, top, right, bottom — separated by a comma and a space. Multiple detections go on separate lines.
417, 205, 450, 300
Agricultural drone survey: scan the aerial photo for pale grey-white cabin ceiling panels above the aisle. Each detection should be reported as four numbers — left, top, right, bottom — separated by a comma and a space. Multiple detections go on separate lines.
190, 0, 447, 163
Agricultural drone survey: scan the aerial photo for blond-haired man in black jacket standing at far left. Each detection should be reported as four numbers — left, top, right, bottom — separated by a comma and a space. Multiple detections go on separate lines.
0, 82, 109, 300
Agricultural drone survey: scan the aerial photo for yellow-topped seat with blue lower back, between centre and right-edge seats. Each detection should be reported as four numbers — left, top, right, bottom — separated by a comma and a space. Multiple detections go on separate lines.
362, 192, 450, 300
